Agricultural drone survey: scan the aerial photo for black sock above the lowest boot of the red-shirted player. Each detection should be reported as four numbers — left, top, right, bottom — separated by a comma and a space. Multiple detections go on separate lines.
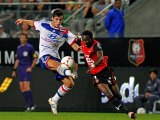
109, 97, 129, 114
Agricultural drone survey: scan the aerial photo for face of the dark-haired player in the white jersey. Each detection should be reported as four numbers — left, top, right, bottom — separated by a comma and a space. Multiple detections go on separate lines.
52, 16, 63, 28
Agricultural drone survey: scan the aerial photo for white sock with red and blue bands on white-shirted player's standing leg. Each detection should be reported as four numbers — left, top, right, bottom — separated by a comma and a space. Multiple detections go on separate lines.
53, 84, 71, 102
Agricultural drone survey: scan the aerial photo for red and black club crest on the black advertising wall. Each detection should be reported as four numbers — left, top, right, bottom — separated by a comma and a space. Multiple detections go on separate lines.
128, 39, 145, 66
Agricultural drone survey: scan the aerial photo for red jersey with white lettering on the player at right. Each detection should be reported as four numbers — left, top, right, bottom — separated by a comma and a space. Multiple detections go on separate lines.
81, 40, 108, 74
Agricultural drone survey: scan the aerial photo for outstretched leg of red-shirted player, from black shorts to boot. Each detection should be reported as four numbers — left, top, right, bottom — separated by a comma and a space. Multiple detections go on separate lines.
95, 67, 135, 119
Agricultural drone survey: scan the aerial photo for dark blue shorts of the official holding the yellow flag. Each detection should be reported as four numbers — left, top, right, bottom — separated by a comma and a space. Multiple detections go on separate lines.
17, 65, 31, 82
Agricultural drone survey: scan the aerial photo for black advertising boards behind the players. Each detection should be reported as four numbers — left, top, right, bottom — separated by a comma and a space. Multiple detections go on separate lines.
0, 38, 160, 112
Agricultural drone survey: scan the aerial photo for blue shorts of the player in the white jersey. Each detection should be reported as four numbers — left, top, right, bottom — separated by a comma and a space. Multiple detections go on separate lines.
39, 55, 67, 81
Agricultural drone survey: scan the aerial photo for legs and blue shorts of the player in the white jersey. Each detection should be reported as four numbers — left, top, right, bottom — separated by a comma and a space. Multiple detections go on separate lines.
40, 55, 74, 114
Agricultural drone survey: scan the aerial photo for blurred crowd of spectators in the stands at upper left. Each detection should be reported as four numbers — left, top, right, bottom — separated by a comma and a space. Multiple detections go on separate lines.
0, 0, 136, 38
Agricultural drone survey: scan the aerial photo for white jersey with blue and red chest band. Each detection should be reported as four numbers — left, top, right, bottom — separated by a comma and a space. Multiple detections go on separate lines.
34, 21, 76, 58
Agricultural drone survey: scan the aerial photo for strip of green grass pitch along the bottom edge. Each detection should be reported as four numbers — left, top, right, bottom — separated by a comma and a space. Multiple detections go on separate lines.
0, 112, 160, 120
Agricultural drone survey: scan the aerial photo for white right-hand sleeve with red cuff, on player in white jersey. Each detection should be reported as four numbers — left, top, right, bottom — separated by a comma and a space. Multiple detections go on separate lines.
66, 31, 77, 46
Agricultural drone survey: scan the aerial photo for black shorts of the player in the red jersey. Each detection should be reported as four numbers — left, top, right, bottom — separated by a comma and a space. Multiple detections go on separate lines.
92, 66, 117, 86
